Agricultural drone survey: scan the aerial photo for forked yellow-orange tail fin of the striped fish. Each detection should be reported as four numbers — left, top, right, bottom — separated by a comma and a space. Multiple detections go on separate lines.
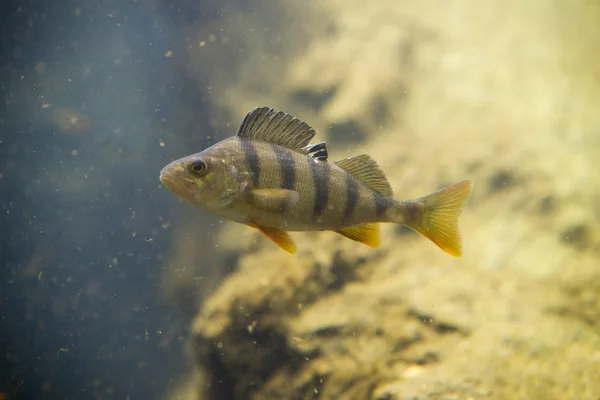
406, 181, 473, 257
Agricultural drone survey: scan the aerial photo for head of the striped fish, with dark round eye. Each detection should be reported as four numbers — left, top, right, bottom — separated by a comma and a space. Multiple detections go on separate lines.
160, 151, 246, 211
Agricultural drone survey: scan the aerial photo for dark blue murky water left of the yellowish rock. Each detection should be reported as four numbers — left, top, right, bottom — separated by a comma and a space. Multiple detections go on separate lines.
0, 0, 220, 399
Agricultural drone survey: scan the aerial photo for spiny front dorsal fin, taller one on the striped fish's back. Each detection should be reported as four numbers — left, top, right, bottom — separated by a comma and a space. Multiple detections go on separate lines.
236, 107, 316, 153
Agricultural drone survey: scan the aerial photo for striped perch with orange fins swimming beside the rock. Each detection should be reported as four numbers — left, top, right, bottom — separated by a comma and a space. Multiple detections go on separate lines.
160, 106, 473, 257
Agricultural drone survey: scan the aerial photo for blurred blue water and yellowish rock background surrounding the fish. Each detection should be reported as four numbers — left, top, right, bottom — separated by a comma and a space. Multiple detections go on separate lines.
0, 0, 600, 400
